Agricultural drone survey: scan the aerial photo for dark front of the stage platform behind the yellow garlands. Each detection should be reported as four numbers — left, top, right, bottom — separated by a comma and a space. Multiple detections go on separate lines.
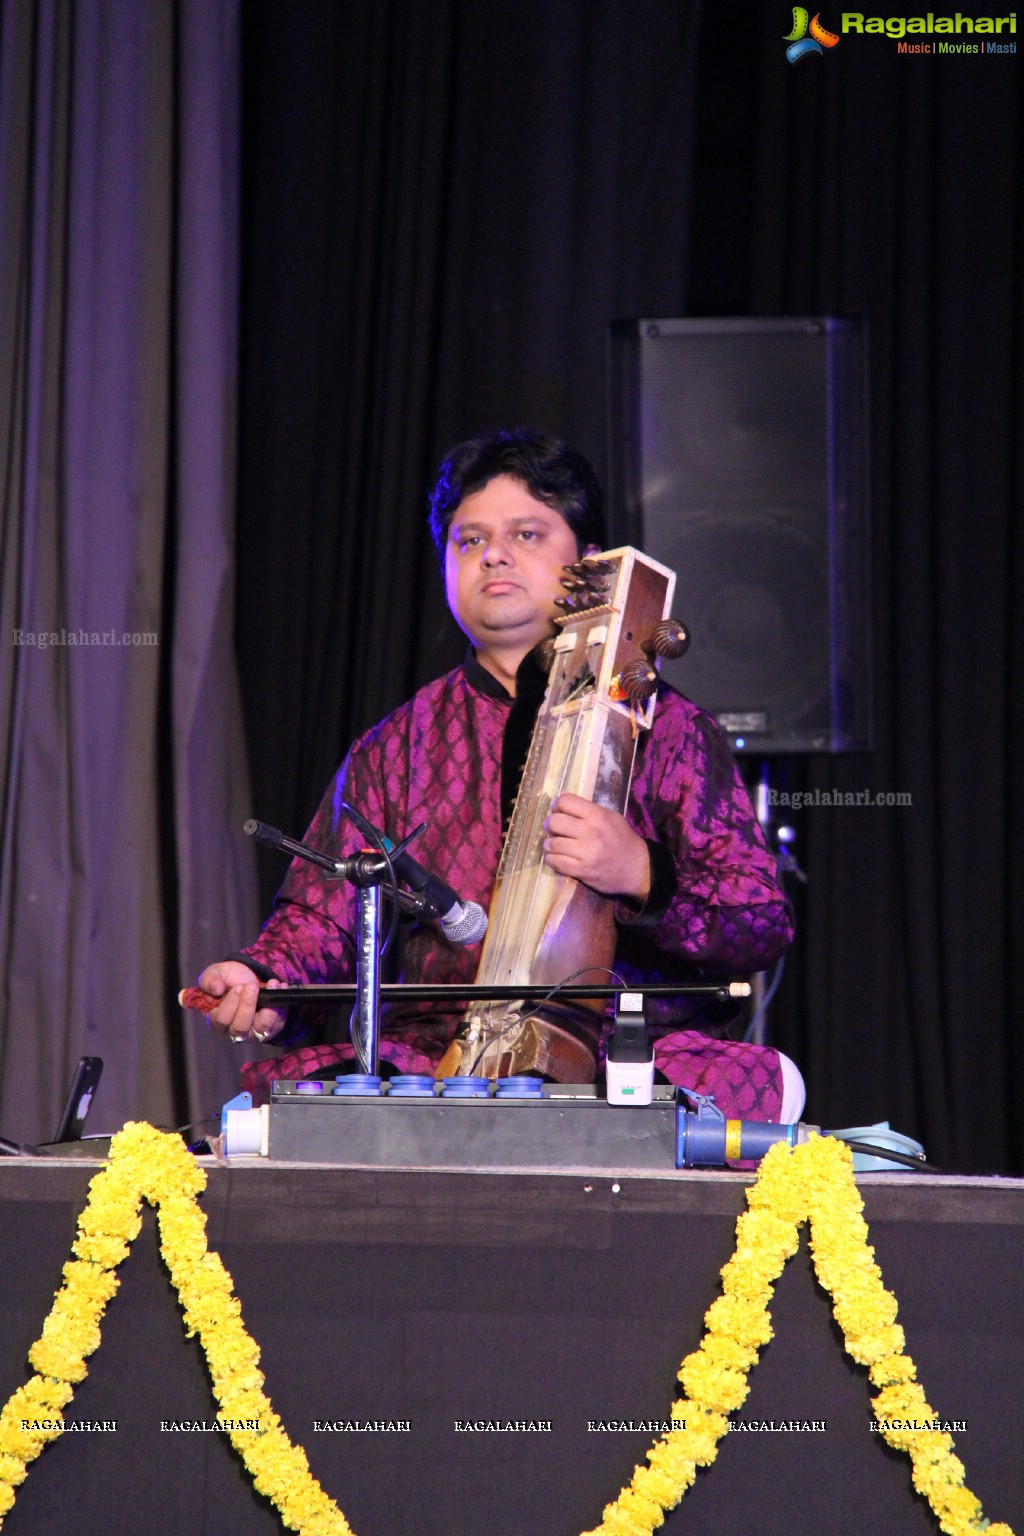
0, 1158, 1024, 1536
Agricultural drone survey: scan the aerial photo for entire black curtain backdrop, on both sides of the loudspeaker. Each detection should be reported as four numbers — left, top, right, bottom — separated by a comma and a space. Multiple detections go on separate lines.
238, 0, 1024, 1170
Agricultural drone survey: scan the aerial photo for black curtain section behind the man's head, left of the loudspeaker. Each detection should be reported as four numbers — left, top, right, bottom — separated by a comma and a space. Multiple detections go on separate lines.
238, 0, 697, 835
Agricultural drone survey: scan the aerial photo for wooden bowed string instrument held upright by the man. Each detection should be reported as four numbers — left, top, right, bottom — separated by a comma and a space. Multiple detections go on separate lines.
438, 548, 676, 1083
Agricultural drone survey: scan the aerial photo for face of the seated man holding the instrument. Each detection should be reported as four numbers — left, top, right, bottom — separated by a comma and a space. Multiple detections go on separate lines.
445, 475, 589, 656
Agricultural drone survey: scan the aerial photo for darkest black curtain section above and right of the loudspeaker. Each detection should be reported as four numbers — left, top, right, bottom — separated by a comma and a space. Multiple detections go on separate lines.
689, 6, 1024, 1170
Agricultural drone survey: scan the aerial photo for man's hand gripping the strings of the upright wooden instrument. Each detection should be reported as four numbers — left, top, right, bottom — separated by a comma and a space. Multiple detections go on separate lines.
543, 794, 651, 905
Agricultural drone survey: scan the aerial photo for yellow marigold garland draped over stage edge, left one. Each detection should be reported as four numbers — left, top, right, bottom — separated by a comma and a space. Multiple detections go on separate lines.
0, 1124, 352, 1536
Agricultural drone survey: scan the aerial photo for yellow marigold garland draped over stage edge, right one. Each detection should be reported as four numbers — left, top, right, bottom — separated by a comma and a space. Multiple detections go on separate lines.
585, 1137, 1013, 1536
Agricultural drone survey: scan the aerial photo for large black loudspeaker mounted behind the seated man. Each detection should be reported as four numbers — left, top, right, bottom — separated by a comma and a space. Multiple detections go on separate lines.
609, 318, 870, 753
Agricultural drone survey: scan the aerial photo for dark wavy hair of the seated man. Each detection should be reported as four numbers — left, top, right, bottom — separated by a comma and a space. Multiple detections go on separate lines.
430, 427, 606, 564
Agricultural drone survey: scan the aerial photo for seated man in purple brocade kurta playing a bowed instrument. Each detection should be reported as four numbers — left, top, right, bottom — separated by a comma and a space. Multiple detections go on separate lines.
190, 432, 801, 1120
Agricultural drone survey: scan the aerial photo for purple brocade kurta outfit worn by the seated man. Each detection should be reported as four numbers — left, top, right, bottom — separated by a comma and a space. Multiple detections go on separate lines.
238, 656, 792, 1120
